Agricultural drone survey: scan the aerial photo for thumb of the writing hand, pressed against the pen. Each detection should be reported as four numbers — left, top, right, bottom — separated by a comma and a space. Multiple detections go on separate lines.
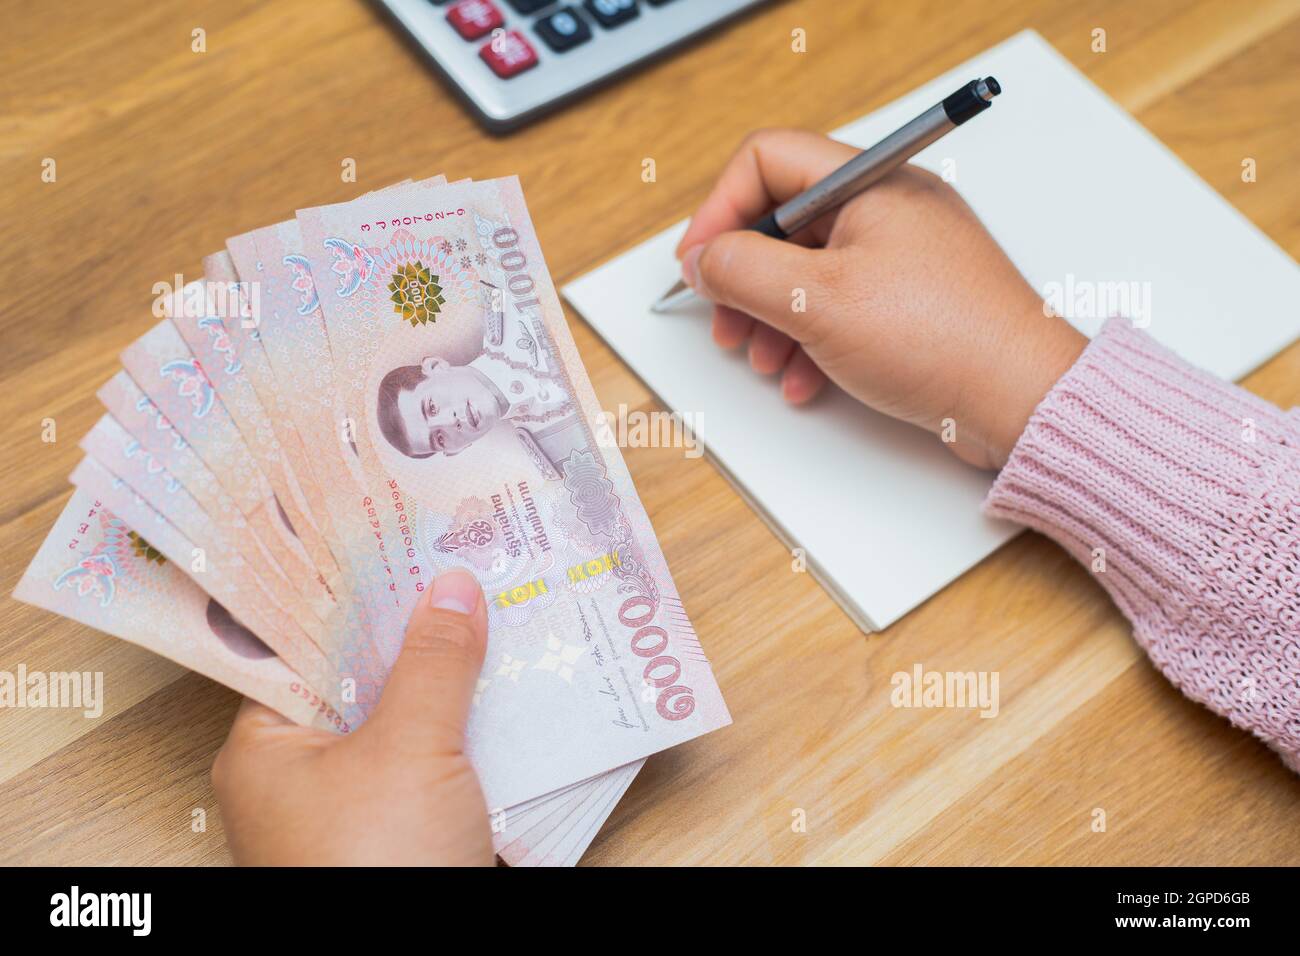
681, 230, 836, 343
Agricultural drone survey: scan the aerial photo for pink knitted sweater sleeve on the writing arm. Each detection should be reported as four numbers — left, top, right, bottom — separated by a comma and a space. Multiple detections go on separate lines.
984, 319, 1300, 771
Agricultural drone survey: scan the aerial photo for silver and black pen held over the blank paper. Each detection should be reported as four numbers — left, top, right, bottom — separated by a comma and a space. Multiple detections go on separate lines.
651, 77, 1002, 312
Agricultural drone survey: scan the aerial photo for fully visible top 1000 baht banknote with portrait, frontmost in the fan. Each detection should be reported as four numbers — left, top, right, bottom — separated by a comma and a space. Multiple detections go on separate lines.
288, 178, 729, 806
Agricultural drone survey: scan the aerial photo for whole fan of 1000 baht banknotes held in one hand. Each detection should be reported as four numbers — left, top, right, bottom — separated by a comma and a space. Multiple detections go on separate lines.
16, 177, 731, 865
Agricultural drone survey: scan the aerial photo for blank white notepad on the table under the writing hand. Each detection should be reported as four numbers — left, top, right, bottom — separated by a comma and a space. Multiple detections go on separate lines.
564, 31, 1300, 630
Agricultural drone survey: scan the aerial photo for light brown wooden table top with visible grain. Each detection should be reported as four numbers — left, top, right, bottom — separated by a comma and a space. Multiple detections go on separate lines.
0, 0, 1300, 864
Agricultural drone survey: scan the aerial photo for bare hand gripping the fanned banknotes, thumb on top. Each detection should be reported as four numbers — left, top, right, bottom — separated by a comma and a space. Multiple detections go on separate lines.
212, 571, 493, 866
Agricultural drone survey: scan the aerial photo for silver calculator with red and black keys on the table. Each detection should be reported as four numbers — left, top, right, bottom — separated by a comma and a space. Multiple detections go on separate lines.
380, 0, 764, 131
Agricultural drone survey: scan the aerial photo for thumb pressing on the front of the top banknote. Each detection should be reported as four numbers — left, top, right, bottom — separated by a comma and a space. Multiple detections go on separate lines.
363, 570, 488, 756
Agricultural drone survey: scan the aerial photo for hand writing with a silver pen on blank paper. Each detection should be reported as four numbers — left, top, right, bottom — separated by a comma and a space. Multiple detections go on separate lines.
677, 130, 1086, 468
